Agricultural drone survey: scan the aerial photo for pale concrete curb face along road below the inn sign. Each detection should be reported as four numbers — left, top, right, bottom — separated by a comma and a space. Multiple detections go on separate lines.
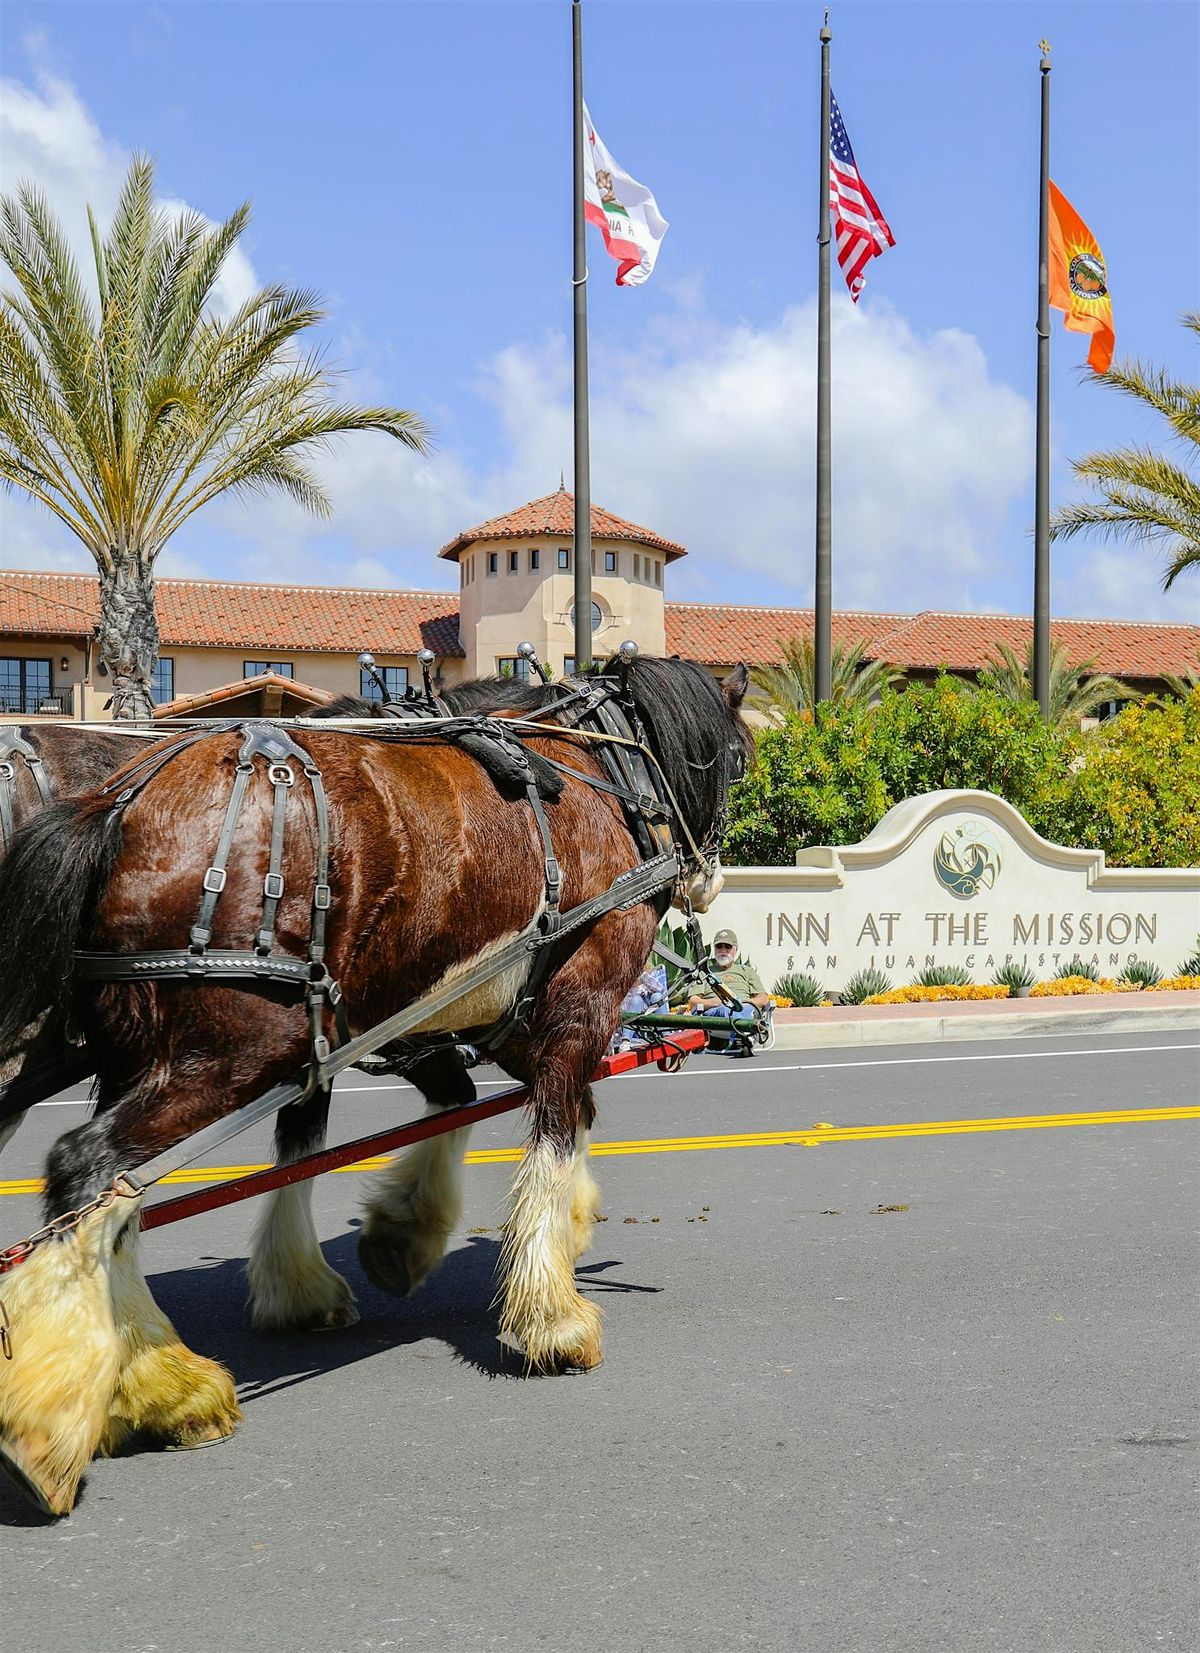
775, 1005, 1200, 1050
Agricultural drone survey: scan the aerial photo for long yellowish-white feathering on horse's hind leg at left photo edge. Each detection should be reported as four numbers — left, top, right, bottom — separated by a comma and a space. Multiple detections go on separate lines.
0, 1197, 132, 1516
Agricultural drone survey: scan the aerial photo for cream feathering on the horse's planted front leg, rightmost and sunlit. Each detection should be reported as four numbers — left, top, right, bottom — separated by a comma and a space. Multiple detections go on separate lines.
501, 1141, 600, 1372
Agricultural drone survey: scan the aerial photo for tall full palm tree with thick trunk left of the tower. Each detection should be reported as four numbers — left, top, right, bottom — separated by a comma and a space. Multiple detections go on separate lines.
0, 155, 426, 717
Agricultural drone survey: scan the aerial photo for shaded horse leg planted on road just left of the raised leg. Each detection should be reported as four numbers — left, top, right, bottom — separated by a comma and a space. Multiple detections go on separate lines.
246, 1091, 359, 1331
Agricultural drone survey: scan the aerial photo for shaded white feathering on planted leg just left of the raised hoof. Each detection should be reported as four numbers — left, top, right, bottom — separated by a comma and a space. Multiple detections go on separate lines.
246, 1182, 359, 1331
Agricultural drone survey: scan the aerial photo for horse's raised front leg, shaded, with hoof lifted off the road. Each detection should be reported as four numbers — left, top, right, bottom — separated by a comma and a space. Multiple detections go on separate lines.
359, 1051, 474, 1298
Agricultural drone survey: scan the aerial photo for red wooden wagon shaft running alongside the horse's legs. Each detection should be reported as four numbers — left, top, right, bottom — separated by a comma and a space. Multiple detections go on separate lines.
142, 1028, 706, 1228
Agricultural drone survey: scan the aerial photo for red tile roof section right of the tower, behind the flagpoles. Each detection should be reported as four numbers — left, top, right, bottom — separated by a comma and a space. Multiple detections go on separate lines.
666, 603, 1200, 679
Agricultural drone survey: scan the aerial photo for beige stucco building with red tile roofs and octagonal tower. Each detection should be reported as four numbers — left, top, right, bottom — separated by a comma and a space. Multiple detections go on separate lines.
0, 488, 1200, 719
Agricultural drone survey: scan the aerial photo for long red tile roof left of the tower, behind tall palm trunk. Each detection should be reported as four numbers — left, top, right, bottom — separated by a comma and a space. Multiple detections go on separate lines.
0, 572, 463, 656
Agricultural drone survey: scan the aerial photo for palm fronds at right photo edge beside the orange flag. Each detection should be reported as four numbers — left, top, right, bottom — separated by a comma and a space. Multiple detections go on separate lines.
1050, 312, 1200, 590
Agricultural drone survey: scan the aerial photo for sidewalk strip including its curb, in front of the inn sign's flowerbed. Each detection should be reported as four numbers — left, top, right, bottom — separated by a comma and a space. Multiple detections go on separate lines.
775, 992, 1200, 1050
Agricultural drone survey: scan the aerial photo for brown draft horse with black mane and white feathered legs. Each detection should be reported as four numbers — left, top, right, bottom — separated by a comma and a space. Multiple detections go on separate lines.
0, 660, 749, 1514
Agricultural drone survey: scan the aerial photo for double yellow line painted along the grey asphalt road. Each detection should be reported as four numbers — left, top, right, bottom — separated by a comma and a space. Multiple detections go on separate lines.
0, 1108, 1200, 1195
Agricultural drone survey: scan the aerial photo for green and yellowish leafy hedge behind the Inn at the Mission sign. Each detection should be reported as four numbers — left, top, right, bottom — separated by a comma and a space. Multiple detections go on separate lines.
724, 676, 1200, 866
